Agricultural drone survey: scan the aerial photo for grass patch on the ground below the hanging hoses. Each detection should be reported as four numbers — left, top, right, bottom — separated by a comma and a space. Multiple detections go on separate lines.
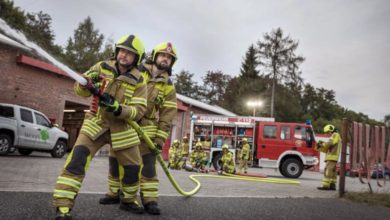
345, 192, 390, 208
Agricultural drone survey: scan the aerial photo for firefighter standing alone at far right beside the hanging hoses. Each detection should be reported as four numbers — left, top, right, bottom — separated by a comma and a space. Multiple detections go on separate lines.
317, 125, 341, 190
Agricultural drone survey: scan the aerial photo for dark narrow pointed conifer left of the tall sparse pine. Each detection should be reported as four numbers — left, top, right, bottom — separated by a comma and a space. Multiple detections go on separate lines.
240, 44, 259, 78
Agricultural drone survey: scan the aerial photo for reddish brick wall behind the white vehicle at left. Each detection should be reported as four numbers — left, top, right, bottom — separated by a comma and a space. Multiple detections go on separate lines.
0, 44, 89, 125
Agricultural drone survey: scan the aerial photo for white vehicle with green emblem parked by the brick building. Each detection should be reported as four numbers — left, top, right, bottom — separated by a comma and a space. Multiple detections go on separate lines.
0, 103, 69, 158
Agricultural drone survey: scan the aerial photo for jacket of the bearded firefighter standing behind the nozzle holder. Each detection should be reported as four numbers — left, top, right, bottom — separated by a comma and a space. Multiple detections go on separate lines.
139, 64, 177, 146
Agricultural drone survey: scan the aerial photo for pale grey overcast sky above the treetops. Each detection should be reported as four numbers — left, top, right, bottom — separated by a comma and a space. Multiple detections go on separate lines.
14, 0, 390, 120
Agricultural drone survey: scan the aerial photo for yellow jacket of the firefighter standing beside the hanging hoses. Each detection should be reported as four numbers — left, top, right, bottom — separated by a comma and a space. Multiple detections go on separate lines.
317, 132, 341, 161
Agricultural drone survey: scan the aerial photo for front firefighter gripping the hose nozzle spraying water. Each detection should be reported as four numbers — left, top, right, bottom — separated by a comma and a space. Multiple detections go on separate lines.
53, 35, 147, 219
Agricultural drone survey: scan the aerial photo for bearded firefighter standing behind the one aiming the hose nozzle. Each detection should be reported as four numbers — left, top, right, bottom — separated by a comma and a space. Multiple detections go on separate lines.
99, 42, 177, 215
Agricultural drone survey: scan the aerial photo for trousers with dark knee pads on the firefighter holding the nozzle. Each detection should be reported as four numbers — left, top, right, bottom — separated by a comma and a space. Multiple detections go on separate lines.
53, 132, 141, 208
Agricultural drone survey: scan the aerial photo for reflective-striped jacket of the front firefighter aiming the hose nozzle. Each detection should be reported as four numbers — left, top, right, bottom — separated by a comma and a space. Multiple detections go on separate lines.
74, 60, 147, 150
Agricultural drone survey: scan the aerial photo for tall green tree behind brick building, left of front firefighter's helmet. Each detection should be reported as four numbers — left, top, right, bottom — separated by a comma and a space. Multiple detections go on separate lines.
64, 17, 104, 73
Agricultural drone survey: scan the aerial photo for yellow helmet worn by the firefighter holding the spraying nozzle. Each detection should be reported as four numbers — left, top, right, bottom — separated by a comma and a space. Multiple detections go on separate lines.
114, 34, 145, 65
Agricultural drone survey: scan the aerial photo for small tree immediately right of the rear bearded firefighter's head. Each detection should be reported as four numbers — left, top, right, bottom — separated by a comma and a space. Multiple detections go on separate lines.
175, 70, 199, 99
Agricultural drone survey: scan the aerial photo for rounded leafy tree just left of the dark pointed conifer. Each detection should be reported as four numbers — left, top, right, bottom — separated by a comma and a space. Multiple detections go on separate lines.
202, 71, 231, 105
